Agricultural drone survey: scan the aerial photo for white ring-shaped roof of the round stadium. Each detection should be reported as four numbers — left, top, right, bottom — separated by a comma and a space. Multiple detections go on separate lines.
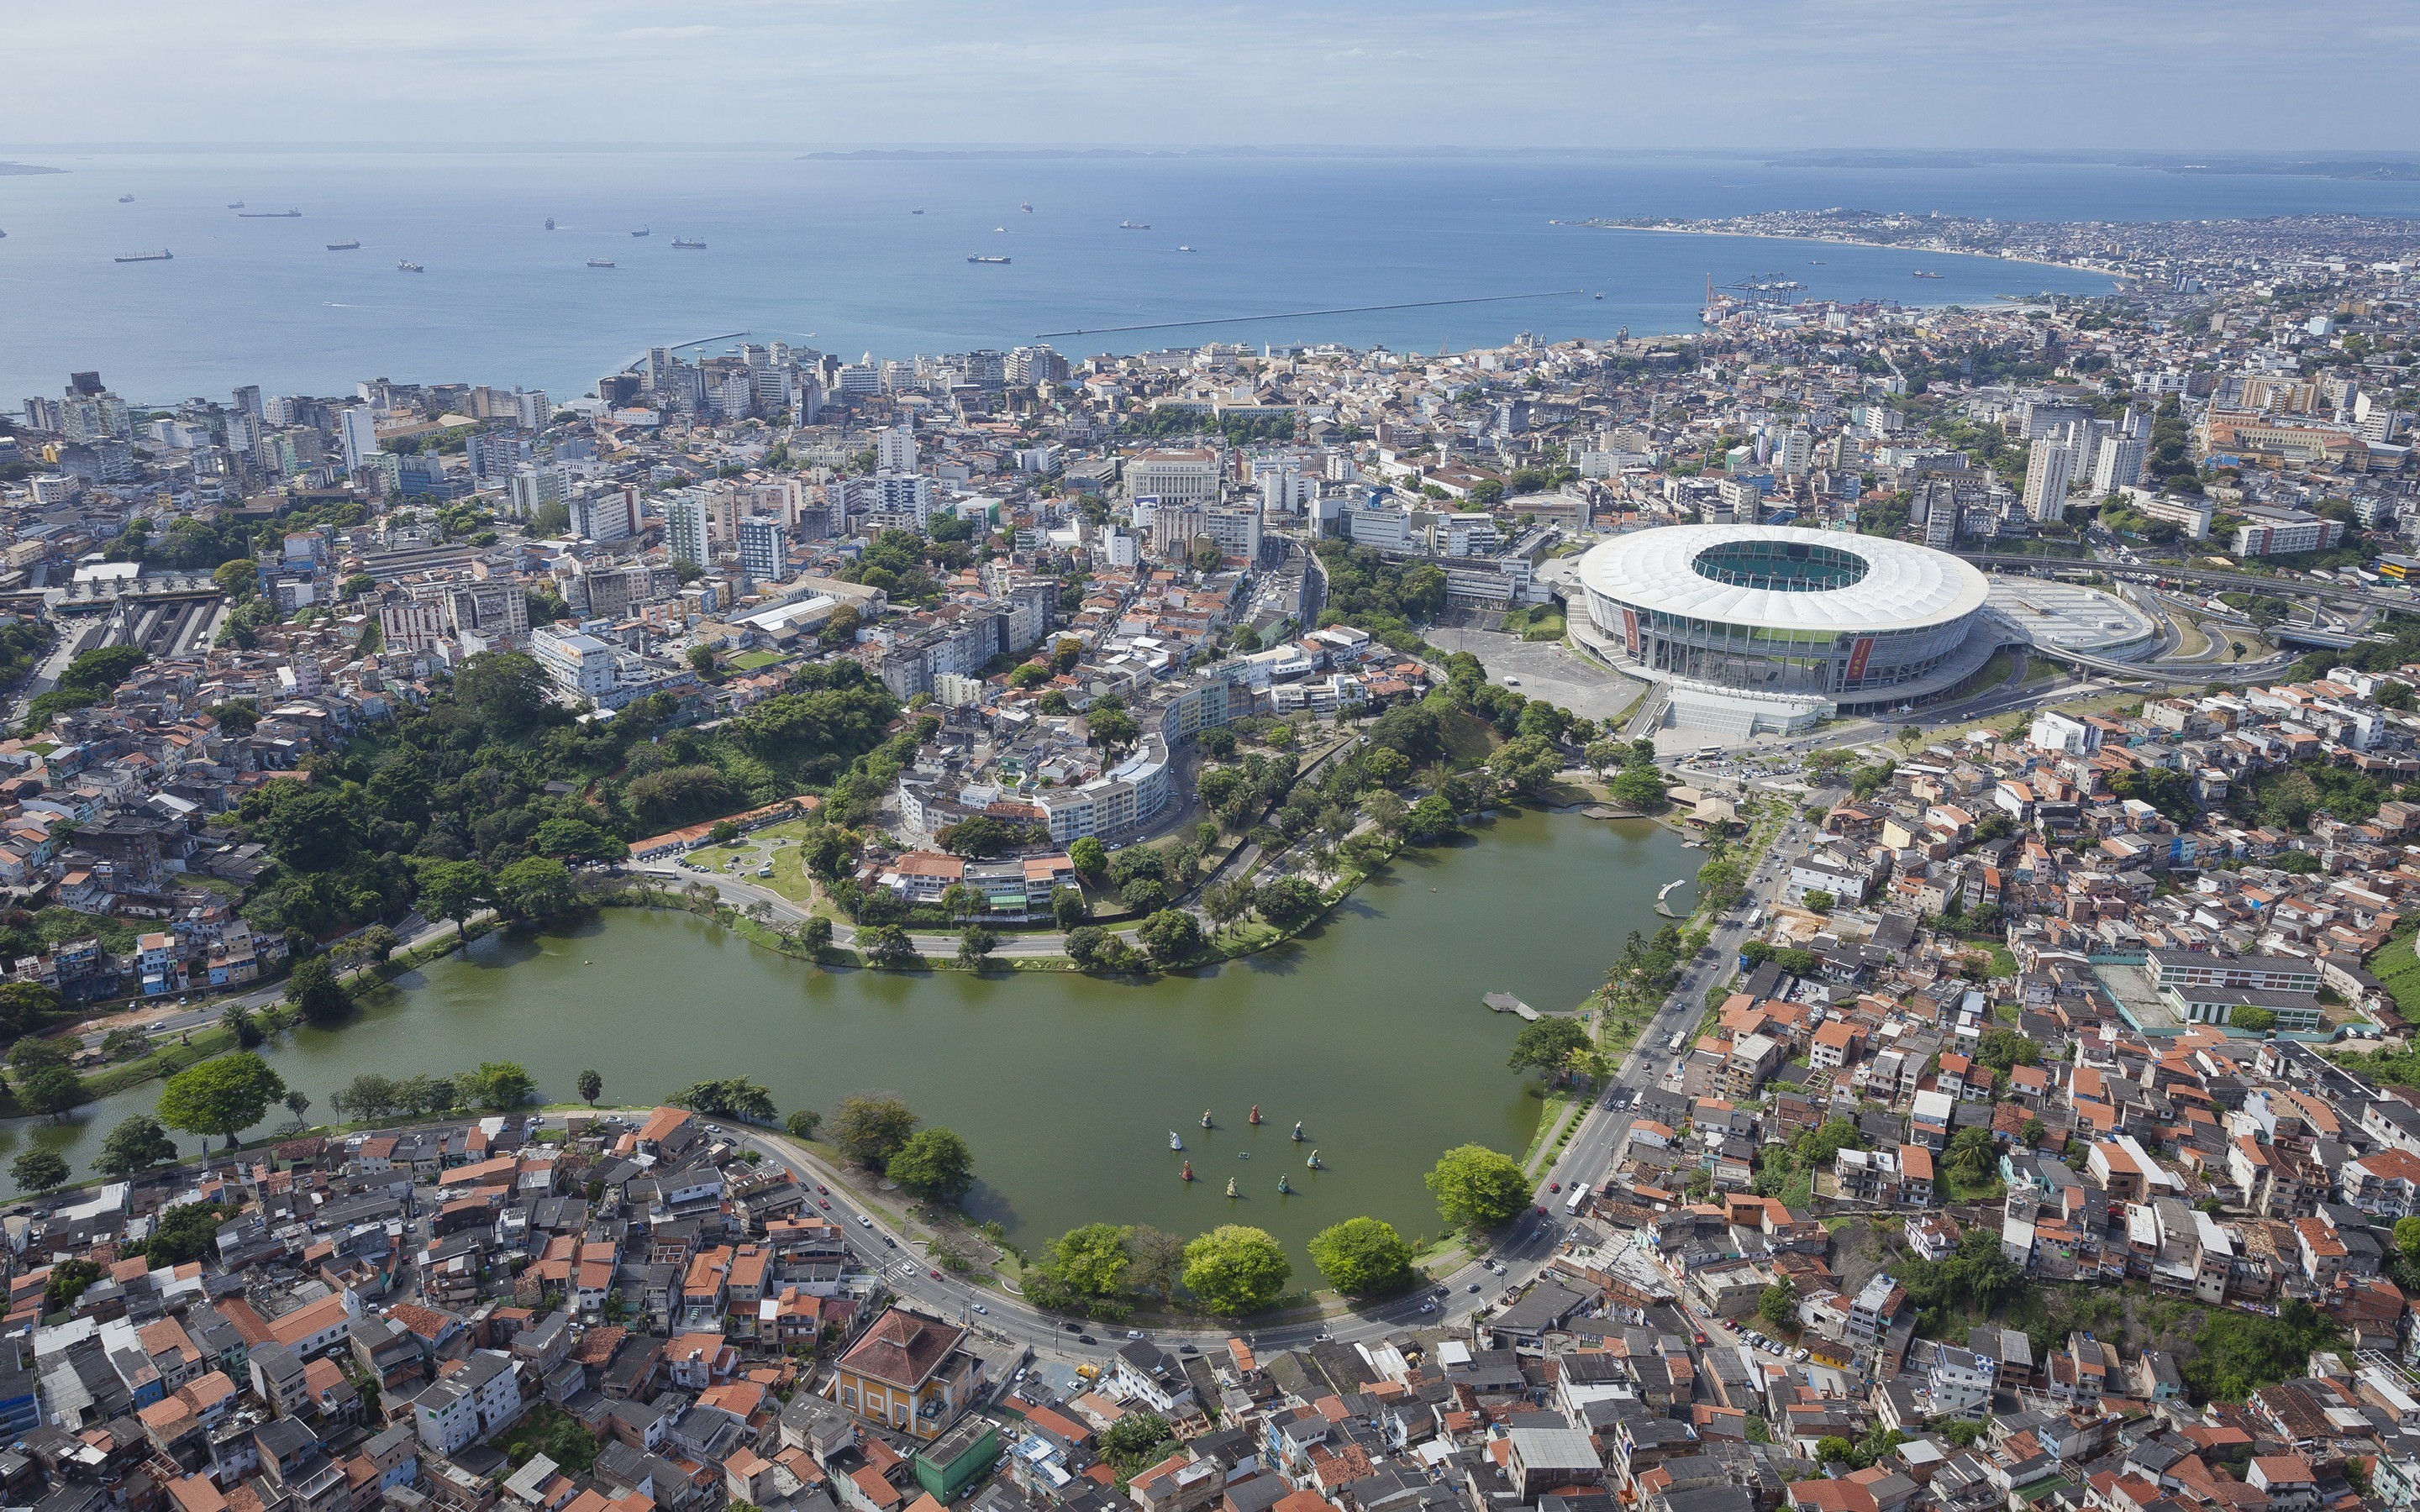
1581, 525, 1989, 632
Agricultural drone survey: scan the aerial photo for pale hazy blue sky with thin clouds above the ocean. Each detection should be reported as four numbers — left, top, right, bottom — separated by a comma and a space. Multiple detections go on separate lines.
0, 0, 2420, 152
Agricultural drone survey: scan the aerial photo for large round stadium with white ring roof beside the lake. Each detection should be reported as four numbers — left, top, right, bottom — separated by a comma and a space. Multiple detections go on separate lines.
1578, 525, 2008, 736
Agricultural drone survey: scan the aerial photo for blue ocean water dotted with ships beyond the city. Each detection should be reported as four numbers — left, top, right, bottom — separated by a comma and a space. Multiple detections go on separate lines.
0, 148, 2420, 409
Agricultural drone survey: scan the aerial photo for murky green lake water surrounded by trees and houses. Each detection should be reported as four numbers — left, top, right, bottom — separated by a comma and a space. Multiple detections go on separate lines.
0, 813, 1699, 1275
